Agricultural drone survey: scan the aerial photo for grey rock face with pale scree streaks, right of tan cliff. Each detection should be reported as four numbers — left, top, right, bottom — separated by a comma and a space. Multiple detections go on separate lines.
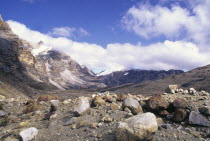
37, 50, 105, 89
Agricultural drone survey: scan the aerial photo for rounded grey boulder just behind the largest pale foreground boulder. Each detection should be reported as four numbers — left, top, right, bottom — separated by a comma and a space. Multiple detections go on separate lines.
122, 97, 142, 115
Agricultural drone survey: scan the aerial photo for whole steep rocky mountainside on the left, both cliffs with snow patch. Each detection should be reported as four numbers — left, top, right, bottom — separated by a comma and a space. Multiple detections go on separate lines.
0, 16, 105, 89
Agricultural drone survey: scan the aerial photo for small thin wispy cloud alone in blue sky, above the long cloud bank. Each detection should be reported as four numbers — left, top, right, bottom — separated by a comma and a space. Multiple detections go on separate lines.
48, 27, 89, 38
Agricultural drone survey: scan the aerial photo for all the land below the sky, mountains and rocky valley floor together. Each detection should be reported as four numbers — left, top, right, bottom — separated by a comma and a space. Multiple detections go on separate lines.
0, 18, 210, 141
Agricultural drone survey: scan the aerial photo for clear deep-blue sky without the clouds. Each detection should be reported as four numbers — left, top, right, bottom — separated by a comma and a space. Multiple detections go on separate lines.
0, 0, 147, 46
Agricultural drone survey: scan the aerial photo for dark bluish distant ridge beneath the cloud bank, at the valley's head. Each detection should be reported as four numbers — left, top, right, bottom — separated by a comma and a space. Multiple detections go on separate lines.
101, 69, 183, 86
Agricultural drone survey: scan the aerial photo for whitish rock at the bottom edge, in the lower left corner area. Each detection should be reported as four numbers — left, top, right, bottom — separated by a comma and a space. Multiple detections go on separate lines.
19, 127, 39, 141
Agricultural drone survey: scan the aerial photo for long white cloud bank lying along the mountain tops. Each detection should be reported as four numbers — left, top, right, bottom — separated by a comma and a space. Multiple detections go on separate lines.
8, 21, 210, 72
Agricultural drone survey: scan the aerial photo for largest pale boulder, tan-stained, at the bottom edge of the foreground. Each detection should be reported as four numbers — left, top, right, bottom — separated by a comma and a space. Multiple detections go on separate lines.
116, 112, 158, 141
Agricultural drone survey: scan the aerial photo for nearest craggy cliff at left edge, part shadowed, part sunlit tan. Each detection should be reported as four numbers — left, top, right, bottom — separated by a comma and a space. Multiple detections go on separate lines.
0, 16, 47, 82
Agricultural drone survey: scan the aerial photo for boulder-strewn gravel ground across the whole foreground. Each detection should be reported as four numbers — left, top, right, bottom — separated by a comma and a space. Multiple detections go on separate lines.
0, 85, 210, 141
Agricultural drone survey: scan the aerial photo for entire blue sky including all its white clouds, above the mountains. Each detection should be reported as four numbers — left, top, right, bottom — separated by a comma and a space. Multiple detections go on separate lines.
0, 0, 210, 72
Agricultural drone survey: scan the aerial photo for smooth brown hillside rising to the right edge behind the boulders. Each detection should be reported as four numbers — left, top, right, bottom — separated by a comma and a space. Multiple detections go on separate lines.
106, 65, 210, 94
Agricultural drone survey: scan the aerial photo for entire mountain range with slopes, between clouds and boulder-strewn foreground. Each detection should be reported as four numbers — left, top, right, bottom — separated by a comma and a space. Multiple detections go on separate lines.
0, 18, 210, 96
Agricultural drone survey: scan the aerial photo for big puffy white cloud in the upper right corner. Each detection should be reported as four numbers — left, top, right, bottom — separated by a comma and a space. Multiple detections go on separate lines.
122, 0, 210, 43
